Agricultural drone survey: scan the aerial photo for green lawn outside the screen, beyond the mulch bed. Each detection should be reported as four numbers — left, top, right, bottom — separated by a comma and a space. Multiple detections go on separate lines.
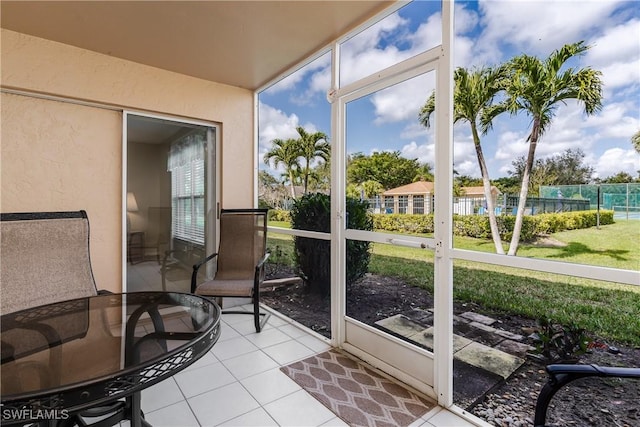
269, 221, 640, 346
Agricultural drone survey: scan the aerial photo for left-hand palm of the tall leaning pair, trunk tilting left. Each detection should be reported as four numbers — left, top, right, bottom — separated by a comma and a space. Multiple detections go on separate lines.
418, 66, 506, 254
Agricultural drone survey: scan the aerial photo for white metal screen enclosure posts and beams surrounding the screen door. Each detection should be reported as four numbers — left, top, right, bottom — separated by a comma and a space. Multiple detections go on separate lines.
254, 0, 640, 421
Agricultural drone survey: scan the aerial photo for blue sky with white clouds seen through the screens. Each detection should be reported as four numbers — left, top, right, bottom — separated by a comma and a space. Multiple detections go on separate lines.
259, 0, 640, 179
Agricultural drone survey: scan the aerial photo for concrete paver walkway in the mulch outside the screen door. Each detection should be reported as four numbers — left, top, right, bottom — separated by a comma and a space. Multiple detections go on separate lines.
376, 309, 533, 408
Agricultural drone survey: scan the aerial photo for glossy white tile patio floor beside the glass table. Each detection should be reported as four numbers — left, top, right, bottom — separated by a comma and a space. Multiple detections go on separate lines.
135, 306, 473, 427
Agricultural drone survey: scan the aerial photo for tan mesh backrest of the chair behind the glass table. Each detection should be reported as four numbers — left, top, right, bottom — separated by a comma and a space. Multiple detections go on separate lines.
0, 211, 97, 314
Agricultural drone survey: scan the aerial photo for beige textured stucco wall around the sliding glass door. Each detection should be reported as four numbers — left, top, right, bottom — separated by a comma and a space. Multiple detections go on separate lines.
0, 29, 254, 291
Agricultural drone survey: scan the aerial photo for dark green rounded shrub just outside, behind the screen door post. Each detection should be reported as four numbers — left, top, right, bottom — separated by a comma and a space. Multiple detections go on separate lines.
291, 193, 373, 296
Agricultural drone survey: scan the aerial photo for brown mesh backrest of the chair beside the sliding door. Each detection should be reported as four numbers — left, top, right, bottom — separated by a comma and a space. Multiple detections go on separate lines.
215, 209, 268, 279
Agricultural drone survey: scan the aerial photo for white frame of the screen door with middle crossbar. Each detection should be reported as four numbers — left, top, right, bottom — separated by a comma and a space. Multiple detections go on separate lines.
330, 40, 452, 398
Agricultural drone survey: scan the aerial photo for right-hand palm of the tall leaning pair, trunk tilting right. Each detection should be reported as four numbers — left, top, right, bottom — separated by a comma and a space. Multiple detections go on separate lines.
502, 41, 602, 255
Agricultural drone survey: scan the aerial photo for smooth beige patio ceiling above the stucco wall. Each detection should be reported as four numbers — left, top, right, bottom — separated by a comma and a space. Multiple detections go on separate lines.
0, 0, 394, 90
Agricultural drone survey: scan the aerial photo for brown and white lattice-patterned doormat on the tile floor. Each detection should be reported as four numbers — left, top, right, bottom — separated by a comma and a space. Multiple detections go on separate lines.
280, 350, 436, 427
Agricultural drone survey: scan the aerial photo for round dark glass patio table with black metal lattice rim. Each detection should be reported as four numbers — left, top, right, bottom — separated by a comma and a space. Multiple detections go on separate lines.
0, 292, 220, 427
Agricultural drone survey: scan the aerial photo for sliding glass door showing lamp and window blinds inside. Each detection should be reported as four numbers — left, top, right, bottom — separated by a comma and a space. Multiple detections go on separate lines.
125, 114, 219, 292
